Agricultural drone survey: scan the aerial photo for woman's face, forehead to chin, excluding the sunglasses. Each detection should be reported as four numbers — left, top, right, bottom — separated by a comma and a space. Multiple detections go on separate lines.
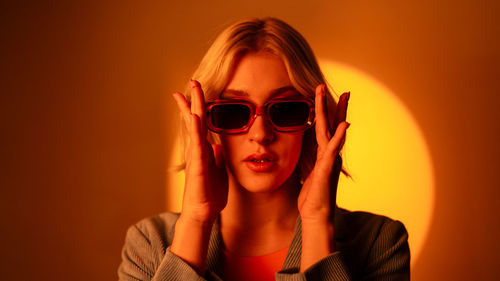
221, 52, 304, 192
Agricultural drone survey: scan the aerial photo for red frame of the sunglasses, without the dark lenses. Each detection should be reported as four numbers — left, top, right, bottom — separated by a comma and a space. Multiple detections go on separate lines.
205, 96, 316, 135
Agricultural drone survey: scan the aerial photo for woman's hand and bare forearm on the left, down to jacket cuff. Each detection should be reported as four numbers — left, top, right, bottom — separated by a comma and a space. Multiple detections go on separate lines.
170, 80, 228, 276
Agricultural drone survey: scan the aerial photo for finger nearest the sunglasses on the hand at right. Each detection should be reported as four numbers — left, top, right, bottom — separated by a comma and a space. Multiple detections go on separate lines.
315, 84, 331, 150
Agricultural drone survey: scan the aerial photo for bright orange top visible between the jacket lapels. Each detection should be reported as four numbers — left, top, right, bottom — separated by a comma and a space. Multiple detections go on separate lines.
223, 248, 288, 281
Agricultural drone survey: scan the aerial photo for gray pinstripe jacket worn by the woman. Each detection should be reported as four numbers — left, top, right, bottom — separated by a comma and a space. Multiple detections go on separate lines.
118, 208, 410, 281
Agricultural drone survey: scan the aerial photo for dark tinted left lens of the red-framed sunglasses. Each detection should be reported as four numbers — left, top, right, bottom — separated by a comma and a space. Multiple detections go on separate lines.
210, 104, 250, 130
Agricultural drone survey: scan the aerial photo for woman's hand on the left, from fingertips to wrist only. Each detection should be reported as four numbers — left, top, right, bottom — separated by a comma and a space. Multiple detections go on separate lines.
173, 80, 228, 225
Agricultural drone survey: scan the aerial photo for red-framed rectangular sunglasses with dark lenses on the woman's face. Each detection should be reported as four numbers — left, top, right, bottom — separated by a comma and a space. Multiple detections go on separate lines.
206, 97, 315, 134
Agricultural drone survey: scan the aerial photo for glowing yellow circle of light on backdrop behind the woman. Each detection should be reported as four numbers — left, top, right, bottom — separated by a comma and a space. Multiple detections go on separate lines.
320, 60, 434, 263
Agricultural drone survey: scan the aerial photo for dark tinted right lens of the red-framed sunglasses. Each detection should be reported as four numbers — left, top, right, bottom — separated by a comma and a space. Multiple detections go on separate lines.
269, 101, 309, 127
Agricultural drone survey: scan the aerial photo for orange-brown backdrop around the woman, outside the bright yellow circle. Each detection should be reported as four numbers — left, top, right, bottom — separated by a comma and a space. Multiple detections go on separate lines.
0, 0, 500, 280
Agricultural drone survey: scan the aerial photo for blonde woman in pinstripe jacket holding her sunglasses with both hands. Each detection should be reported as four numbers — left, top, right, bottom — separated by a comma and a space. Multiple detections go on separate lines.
118, 18, 410, 280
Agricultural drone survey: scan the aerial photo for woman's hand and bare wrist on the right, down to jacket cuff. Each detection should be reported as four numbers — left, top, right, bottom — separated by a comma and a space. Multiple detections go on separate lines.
298, 85, 349, 271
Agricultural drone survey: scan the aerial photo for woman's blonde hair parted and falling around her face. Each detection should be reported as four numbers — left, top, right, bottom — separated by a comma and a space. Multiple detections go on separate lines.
181, 17, 348, 180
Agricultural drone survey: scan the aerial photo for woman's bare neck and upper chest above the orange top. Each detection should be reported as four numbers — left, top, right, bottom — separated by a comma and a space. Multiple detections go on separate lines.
220, 174, 299, 256
